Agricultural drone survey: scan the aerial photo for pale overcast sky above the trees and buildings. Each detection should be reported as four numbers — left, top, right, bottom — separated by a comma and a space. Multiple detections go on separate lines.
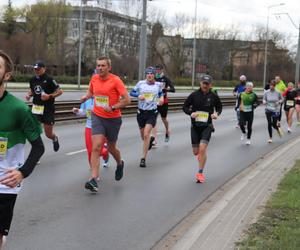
5, 0, 300, 50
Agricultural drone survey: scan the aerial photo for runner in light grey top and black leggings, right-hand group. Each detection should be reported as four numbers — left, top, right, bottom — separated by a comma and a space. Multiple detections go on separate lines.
263, 80, 283, 143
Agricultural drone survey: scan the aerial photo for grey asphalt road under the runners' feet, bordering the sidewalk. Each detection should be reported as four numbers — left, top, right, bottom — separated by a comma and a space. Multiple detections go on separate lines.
5, 108, 300, 250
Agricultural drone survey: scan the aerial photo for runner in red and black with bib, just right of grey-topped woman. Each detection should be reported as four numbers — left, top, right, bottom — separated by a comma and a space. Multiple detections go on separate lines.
282, 82, 296, 133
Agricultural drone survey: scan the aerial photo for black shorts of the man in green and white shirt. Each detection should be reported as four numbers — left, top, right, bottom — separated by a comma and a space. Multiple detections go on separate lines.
0, 194, 17, 235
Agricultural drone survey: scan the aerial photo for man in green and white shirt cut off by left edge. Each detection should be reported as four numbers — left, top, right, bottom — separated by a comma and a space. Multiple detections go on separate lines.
0, 51, 44, 249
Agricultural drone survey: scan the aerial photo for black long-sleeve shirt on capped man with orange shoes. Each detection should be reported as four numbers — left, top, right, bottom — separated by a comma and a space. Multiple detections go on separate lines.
183, 88, 222, 125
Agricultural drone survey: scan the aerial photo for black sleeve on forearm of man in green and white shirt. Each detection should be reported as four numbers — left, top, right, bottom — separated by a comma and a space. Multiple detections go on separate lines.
18, 136, 45, 178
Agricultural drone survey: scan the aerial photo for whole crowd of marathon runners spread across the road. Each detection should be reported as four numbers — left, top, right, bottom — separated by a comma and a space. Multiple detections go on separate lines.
0, 51, 300, 249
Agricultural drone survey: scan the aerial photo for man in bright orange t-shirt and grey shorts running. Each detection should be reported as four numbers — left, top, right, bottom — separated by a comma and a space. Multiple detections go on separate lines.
81, 57, 130, 192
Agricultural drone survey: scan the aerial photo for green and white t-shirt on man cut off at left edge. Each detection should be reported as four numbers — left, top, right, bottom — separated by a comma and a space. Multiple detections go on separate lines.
0, 92, 42, 193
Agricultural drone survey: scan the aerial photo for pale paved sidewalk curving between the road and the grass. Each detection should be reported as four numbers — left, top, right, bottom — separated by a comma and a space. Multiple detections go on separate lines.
153, 137, 300, 250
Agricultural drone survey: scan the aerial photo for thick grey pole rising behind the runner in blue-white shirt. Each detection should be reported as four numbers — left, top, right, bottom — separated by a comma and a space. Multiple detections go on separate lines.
139, 0, 147, 80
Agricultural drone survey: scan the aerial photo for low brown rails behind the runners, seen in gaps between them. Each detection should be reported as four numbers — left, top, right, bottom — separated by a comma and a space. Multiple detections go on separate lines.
28, 96, 260, 122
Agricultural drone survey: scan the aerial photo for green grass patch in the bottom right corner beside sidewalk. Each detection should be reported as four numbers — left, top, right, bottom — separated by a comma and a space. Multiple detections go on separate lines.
236, 160, 300, 250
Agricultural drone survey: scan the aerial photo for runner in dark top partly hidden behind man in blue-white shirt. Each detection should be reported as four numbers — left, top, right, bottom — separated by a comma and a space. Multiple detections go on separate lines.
152, 64, 175, 145
